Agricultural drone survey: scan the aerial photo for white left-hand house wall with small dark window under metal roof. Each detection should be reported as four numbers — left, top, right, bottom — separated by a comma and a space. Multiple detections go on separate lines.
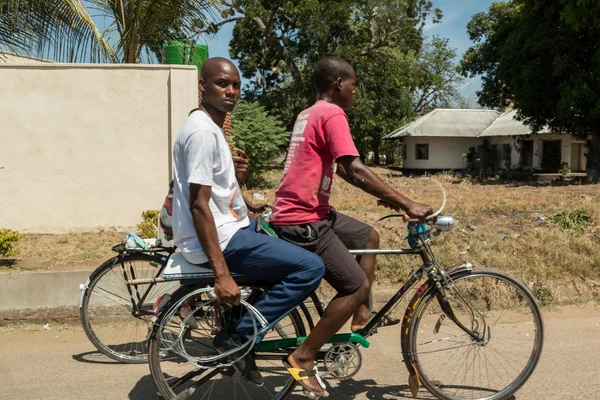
402, 136, 483, 169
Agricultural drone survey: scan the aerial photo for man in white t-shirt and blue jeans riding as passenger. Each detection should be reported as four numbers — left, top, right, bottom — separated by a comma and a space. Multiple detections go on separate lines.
173, 58, 325, 386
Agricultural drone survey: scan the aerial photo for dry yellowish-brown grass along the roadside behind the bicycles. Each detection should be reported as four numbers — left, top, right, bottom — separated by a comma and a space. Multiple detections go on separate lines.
4, 168, 600, 302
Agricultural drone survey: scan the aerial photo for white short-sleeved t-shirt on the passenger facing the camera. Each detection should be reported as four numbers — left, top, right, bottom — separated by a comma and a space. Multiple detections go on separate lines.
173, 110, 250, 264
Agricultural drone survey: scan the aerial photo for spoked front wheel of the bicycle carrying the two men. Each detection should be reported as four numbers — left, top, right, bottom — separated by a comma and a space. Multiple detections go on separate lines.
409, 268, 544, 400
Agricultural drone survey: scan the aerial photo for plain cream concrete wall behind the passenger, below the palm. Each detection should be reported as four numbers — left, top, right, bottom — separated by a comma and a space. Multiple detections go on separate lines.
0, 63, 198, 233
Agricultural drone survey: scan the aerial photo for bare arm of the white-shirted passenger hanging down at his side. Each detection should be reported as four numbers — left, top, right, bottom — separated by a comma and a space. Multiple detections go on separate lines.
190, 183, 240, 305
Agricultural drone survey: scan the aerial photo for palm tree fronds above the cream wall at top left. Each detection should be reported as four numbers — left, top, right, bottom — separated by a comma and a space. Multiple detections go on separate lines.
0, 0, 221, 63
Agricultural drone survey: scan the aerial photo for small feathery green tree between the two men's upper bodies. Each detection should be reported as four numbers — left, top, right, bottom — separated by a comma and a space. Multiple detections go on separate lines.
231, 100, 290, 186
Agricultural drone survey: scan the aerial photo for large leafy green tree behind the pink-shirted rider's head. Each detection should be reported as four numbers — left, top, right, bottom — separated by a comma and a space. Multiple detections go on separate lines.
207, 0, 458, 162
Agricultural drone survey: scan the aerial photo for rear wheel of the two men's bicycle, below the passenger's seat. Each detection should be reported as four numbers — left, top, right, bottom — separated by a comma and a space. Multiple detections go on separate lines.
149, 287, 306, 400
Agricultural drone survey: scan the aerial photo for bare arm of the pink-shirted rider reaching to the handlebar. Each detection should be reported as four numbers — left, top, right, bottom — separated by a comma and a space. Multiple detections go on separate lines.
337, 156, 434, 219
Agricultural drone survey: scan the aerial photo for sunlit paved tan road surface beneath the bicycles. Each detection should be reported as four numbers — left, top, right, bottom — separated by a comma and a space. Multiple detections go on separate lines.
0, 307, 600, 400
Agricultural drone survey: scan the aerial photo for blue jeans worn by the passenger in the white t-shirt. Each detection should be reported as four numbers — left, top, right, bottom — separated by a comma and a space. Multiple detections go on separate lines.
211, 220, 325, 343
